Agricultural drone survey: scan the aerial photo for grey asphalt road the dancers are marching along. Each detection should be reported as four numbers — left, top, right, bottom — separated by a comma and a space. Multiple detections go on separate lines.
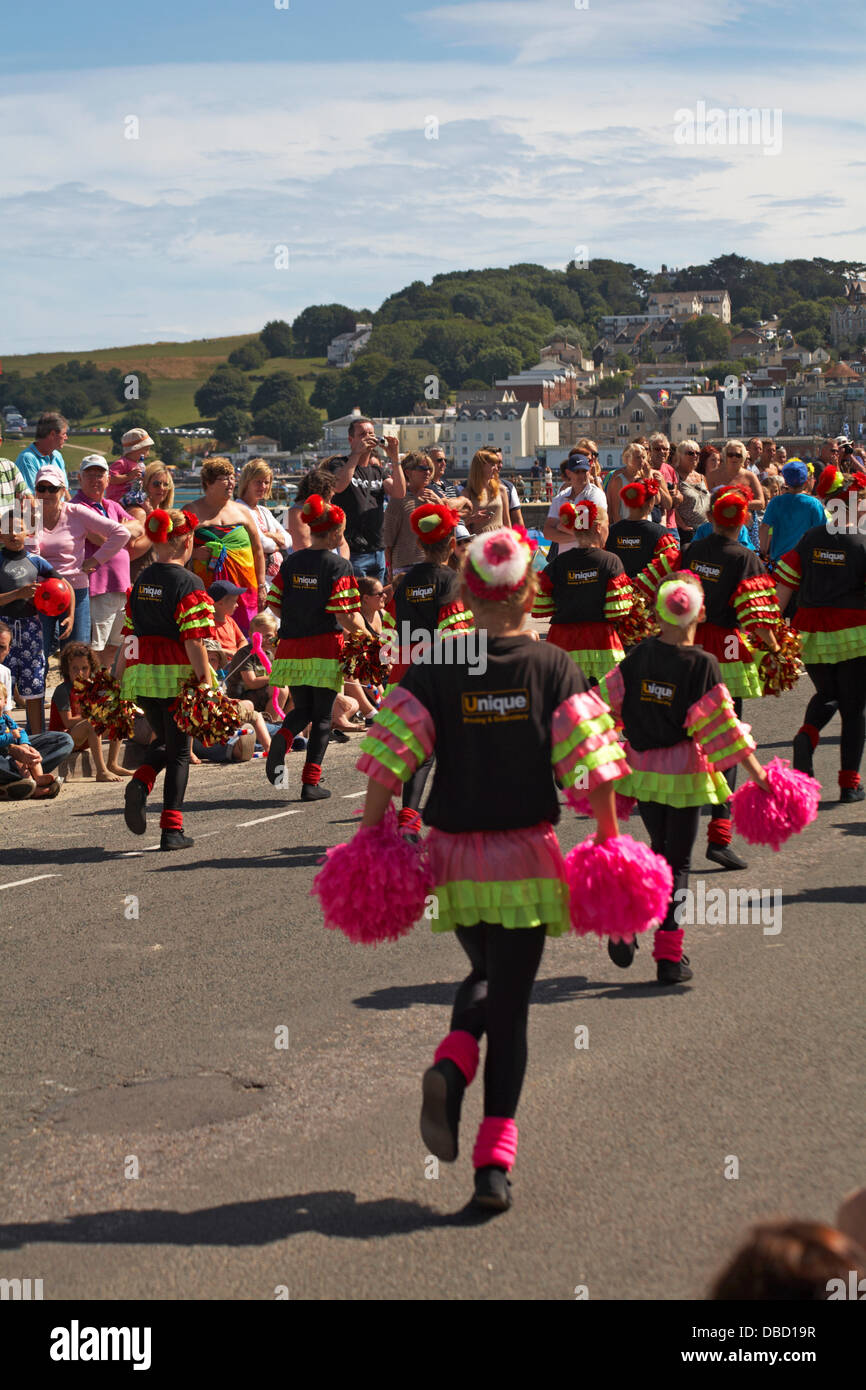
0, 691, 866, 1300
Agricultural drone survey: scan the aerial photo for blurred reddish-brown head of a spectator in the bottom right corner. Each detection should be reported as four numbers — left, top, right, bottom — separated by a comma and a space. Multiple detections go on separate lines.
709, 1220, 866, 1302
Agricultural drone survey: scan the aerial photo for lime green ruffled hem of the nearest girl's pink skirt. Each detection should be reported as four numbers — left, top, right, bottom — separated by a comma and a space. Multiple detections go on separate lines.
431, 878, 571, 937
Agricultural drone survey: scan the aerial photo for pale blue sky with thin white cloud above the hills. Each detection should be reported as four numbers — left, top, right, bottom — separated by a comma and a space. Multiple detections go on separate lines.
0, 0, 866, 356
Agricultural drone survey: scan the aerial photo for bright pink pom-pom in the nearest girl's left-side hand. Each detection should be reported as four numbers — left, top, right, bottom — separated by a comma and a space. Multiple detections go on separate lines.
311, 806, 434, 945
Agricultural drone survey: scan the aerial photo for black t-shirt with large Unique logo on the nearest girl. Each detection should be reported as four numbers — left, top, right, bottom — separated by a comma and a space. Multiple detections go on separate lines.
400, 637, 589, 834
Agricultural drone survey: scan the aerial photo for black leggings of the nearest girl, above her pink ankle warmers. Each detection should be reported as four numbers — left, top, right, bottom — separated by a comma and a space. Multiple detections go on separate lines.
450, 922, 546, 1119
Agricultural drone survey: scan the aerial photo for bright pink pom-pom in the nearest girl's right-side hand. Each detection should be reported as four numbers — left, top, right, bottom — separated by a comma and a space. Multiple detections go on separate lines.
566, 835, 674, 937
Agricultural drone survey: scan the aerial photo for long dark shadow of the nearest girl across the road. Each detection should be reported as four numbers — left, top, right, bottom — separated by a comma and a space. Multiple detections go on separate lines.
0, 1191, 491, 1252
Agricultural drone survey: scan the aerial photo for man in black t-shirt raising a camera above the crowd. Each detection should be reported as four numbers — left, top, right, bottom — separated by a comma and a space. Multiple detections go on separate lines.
328, 417, 406, 584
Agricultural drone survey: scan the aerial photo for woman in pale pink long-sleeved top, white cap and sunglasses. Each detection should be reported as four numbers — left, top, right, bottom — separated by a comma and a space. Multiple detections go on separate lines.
35, 464, 129, 644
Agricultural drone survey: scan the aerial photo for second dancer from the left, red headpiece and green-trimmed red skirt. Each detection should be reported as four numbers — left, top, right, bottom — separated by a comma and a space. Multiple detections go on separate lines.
265, 493, 364, 801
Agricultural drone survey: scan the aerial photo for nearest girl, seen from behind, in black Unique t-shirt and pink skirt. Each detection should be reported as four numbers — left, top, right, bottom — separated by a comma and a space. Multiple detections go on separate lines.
359, 530, 627, 1211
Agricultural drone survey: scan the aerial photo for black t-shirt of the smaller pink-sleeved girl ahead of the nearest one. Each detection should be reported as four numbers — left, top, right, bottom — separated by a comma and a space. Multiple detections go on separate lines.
619, 637, 721, 753
